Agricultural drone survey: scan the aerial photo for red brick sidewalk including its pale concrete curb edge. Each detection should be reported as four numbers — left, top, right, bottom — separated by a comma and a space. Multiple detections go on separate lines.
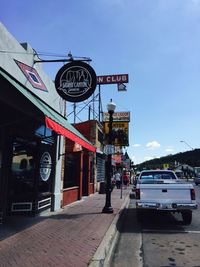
0, 189, 130, 267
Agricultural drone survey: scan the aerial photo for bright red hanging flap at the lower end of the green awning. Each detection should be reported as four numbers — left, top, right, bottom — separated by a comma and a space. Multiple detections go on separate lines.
45, 117, 96, 152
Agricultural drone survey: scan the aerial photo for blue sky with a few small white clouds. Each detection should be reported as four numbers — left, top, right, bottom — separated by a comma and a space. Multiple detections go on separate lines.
0, 0, 200, 163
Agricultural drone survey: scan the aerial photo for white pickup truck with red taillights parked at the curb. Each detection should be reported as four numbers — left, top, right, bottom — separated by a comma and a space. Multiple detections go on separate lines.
135, 170, 197, 225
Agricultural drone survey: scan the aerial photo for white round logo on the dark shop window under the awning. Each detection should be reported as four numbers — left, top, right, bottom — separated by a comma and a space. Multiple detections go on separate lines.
40, 152, 52, 182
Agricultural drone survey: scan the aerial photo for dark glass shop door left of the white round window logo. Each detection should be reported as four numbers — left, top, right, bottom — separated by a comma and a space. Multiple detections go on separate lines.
9, 138, 37, 212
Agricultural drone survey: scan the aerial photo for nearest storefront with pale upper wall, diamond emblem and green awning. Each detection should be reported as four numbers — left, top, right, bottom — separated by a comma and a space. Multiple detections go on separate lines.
0, 24, 95, 223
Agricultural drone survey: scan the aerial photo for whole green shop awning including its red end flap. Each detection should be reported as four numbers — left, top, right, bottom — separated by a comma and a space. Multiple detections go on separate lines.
0, 68, 96, 152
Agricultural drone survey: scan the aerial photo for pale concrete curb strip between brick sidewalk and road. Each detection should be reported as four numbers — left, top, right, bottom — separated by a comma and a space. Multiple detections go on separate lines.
88, 194, 130, 267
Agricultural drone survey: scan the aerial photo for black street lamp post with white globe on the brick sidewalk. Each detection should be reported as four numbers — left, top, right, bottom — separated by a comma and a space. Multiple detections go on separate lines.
102, 99, 116, 213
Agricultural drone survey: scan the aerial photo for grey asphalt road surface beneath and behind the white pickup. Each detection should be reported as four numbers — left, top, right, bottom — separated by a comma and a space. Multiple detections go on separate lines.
111, 183, 200, 267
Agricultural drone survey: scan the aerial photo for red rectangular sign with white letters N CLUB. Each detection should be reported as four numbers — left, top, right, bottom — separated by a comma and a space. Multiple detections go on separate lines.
97, 74, 128, 84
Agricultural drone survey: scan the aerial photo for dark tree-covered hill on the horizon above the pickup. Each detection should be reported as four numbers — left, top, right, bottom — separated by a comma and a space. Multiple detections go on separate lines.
135, 149, 200, 170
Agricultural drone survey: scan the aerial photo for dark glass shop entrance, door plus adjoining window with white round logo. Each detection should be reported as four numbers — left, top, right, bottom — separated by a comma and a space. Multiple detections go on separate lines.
8, 137, 53, 217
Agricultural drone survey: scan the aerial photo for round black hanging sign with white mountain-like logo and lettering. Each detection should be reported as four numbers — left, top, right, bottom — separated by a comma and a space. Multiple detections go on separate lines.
55, 60, 97, 102
